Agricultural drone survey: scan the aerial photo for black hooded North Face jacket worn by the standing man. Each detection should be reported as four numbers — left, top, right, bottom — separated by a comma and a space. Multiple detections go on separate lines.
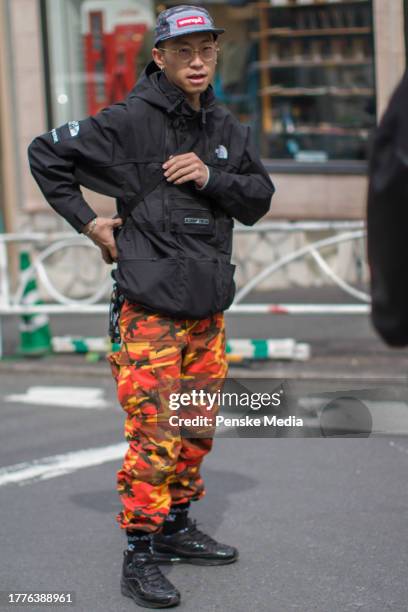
28, 62, 274, 319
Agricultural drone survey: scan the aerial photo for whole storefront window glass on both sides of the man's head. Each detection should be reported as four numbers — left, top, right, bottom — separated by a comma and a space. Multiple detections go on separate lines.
41, 0, 376, 165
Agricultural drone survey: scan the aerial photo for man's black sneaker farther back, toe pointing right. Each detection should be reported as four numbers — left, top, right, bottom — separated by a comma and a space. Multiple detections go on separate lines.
152, 519, 238, 565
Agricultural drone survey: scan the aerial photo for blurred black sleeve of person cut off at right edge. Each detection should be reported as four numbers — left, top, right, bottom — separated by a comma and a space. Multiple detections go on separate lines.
367, 71, 408, 346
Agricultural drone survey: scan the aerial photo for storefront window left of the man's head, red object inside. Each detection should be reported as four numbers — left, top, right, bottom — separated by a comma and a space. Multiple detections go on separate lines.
46, 0, 155, 125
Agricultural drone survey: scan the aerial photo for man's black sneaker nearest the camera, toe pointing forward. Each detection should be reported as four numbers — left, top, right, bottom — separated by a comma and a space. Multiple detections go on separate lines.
120, 550, 180, 608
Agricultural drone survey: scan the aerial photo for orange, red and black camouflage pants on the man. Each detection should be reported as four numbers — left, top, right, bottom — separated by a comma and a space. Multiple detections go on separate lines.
108, 300, 228, 532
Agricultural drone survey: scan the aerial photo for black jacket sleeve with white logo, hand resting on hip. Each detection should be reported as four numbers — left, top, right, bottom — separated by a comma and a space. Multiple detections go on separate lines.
28, 103, 126, 232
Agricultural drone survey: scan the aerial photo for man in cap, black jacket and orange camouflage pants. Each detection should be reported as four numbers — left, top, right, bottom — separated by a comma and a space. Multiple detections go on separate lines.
29, 5, 274, 607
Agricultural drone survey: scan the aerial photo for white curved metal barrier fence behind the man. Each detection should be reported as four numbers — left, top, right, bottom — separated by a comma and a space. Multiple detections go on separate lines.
0, 221, 370, 357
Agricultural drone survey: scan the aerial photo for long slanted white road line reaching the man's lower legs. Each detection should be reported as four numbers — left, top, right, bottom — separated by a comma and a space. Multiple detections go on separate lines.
0, 442, 128, 487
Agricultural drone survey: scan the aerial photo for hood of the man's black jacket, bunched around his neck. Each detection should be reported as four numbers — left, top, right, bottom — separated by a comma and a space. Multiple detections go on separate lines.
128, 61, 215, 124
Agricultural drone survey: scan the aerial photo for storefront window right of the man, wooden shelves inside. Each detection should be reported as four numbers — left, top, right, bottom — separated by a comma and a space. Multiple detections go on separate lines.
256, 0, 376, 162
